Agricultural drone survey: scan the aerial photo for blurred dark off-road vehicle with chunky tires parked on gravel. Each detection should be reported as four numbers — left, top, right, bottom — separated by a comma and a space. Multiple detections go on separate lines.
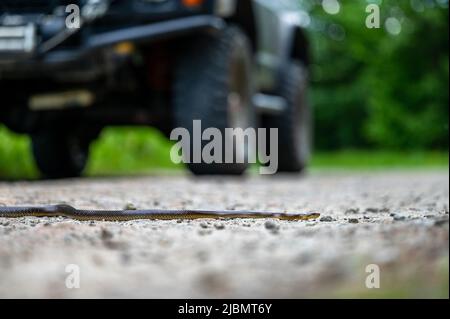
0, 0, 311, 178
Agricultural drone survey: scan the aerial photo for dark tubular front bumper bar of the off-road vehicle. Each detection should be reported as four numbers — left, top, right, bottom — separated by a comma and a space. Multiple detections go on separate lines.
0, 15, 226, 79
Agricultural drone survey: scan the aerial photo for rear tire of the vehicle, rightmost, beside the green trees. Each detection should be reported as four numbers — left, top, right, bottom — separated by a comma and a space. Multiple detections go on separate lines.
263, 62, 312, 173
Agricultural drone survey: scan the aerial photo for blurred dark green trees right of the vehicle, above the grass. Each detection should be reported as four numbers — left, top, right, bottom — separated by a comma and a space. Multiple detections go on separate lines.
303, 0, 449, 149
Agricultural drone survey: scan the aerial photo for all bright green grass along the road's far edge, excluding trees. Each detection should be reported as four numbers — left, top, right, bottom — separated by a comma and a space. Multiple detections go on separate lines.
0, 126, 449, 179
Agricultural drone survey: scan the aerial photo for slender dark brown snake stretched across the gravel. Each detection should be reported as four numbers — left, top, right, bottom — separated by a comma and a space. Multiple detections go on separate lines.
0, 204, 320, 221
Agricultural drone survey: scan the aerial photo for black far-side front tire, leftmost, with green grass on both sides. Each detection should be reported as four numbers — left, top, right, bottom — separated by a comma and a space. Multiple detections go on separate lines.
31, 132, 91, 179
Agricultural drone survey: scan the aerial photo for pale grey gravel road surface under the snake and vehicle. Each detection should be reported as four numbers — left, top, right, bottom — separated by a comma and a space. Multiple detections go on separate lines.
0, 170, 449, 298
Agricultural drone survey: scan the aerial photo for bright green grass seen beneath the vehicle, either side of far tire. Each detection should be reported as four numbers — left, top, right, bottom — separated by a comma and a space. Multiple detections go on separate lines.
0, 126, 183, 179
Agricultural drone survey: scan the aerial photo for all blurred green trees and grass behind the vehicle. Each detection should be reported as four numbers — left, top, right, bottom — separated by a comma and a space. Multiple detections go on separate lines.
0, 0, 449, 178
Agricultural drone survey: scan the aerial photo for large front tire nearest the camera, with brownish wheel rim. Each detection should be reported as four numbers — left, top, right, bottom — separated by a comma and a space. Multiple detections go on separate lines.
173, 26, 255, 175
